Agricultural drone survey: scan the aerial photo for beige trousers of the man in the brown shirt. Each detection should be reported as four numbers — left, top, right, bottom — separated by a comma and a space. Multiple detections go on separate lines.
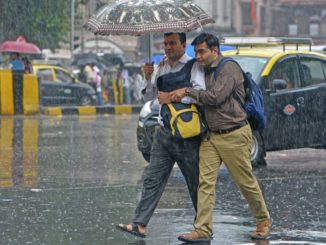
194, 125, 270, 236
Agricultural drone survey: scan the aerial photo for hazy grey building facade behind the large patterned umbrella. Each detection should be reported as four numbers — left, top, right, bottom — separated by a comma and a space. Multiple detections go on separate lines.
75, 0, 326, 60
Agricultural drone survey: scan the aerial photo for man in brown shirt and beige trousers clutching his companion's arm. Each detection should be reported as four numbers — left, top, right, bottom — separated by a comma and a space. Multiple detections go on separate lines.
171, 33, 271, 242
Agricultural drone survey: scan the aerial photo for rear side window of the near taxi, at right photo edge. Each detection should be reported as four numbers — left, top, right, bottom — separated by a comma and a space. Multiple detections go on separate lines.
301, 58, 326, 86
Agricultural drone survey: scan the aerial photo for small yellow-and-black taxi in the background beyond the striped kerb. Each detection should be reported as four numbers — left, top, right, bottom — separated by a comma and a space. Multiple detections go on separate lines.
33, 64, 96, 106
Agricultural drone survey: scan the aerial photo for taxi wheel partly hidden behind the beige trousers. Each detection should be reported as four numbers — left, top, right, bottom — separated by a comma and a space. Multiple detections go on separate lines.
250, 131, 266, 168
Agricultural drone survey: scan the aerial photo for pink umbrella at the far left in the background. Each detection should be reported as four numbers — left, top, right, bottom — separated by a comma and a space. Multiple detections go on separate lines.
0, 36, 41, 54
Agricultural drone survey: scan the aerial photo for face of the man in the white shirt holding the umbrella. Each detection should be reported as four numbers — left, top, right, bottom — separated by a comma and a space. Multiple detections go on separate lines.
164, 33, 186, 61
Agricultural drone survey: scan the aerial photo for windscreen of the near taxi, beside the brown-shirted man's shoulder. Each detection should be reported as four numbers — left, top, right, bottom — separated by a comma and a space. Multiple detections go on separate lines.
232, 56, 268, 81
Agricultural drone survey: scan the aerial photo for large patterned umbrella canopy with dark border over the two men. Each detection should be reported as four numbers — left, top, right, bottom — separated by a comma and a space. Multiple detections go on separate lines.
85, 0, 215, 36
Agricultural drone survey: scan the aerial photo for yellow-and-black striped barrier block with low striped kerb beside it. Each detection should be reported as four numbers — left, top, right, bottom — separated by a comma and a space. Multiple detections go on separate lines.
0, 70, 141, 115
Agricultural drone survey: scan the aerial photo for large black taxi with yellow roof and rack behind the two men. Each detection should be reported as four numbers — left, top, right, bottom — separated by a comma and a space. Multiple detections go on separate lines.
137, 37, 326, 167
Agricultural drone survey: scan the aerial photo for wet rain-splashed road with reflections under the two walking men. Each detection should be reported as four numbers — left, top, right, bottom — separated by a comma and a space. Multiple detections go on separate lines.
0, 115, 326, 245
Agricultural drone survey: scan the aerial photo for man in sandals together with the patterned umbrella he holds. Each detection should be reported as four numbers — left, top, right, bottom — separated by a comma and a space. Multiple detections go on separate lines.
85, 0, 215, 237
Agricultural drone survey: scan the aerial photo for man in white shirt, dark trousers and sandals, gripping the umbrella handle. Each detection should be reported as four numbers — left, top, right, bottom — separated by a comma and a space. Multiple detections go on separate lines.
117, 33, 205, 238
